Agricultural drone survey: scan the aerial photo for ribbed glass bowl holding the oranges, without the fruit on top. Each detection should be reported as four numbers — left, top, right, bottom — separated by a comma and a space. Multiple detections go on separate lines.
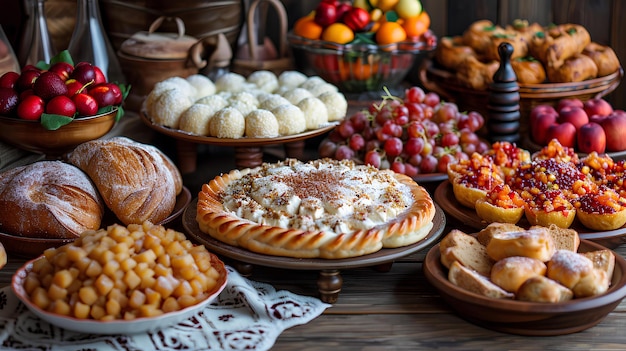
287, 33, 436, 93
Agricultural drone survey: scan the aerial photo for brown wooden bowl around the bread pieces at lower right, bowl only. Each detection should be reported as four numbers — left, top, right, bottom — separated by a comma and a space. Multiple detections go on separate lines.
423, 240, 626, 336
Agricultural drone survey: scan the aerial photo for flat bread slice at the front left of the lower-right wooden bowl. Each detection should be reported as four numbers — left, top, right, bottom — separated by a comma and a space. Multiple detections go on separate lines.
448, 261, 514, 299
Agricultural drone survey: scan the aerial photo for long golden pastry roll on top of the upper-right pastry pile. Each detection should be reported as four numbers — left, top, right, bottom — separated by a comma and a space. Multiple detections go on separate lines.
529, 24, 591, 69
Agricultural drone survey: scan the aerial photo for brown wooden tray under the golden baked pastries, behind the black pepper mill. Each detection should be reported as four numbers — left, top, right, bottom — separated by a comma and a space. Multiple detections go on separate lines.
419, 59, 624, 137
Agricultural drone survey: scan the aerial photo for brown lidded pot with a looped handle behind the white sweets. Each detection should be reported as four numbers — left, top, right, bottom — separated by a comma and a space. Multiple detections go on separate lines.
117, 16, 206, 111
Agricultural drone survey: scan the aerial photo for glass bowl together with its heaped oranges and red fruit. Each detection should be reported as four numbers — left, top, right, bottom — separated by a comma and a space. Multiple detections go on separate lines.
288, 0, 437, 92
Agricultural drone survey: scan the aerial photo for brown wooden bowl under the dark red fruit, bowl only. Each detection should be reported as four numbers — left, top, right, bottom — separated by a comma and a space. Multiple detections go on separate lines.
0, 108, 118, 158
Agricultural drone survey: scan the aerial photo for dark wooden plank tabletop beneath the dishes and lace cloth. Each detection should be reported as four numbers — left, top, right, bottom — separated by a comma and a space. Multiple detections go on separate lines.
0, 223, 626, 351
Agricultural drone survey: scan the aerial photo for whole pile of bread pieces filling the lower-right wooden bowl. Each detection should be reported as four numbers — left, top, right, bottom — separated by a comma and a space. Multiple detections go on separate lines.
439, 223, 615, 303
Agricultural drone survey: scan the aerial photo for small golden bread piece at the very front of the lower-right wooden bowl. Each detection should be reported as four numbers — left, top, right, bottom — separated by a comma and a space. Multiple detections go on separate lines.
515, 275, 574, 303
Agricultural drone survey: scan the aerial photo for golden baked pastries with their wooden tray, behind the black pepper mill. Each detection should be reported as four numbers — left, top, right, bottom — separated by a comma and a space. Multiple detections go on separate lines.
419, 20, 623, 136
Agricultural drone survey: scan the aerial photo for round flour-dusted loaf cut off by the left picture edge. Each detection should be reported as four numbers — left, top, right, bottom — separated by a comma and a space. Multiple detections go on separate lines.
0, 161, 104, 238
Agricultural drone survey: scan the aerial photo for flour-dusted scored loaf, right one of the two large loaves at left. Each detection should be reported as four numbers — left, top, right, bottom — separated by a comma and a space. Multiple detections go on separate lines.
69, 137, 182, 225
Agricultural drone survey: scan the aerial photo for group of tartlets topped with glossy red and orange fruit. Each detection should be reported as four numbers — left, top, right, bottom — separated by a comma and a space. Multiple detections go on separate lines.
448, 139, 626, 231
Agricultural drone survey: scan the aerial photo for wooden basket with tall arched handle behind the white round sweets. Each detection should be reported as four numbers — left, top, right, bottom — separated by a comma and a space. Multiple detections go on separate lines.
232, 0, 293, 76
